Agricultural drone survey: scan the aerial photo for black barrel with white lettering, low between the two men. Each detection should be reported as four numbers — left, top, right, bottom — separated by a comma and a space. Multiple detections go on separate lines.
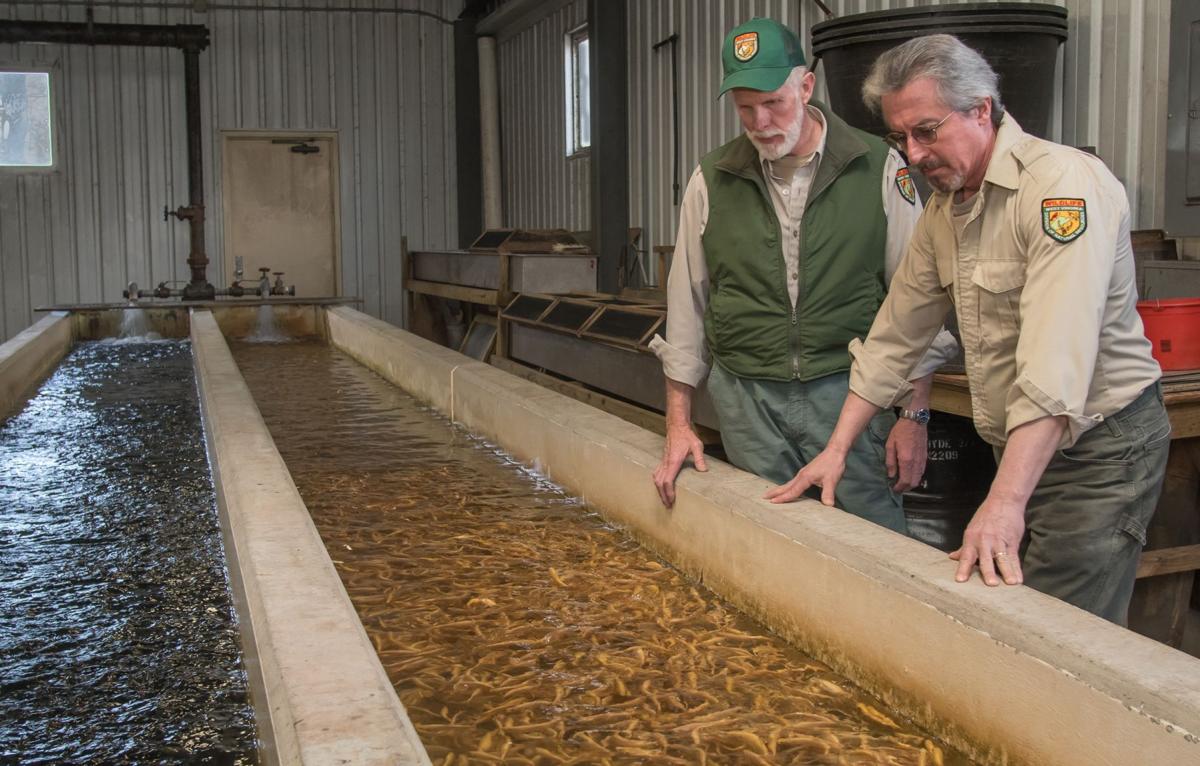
904, 412, 996, 551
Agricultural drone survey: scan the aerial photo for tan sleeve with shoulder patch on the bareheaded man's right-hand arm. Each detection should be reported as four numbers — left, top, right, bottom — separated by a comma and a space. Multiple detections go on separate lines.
1004, 161, 1113, 447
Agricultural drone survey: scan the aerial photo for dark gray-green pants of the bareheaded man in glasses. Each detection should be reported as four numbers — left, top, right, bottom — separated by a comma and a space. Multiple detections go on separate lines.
1021, 383, 1171, 626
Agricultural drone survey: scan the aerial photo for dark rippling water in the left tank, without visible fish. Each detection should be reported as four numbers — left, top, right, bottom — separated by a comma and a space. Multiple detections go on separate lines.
0, 341, 257, 764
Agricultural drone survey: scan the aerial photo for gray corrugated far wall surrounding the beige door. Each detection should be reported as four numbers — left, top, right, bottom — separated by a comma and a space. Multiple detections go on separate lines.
0, 0, 462, 340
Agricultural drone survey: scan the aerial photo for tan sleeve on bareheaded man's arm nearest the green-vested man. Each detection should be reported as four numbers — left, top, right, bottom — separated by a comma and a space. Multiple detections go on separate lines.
850, 204, 953, 407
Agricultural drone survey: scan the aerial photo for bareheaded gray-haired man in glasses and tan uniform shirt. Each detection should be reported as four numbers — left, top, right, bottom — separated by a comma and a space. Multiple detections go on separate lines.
769, 35, 1171, 624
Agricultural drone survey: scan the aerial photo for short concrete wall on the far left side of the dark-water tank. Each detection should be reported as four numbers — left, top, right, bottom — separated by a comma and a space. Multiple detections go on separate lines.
0, 311, 74, 420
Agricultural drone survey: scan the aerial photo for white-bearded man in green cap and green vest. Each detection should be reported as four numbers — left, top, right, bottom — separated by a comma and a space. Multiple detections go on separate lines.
652, 18, 955, 532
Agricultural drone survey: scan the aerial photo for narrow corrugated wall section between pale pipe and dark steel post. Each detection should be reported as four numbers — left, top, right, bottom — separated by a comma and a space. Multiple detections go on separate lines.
497, 0, 592, 231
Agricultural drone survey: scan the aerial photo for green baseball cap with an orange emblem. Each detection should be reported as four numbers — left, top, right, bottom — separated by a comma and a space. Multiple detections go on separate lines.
716, 17, 804, 96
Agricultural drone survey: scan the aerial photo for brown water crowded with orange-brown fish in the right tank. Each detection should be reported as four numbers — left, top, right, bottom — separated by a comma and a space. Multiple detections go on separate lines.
234, 343, 968, 766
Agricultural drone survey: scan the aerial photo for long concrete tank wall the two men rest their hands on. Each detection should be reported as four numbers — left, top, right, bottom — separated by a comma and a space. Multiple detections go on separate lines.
328, 309, 1200, 766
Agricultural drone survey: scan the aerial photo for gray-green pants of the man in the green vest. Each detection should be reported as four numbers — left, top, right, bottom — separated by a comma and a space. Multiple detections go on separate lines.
708, 365, 906, 533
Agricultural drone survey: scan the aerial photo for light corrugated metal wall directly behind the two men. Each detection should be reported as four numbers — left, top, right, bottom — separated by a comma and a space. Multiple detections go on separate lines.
629, 0, 1170, 282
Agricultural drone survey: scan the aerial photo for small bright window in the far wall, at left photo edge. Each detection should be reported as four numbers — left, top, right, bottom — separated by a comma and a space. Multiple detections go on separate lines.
0, 71, 54, 168
